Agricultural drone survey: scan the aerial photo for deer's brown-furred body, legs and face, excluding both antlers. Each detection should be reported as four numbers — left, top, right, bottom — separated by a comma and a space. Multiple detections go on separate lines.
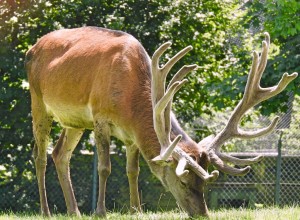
26, 27, 207, 215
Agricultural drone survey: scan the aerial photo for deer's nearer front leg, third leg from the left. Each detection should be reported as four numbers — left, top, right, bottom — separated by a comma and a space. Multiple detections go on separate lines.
94, 120, 111, 217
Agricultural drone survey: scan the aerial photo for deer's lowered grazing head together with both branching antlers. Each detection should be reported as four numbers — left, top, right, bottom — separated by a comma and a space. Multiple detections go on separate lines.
152, 33, 297, 216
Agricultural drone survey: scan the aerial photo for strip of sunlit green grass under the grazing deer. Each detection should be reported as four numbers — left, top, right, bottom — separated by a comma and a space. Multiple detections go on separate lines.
0, 206, 300, 220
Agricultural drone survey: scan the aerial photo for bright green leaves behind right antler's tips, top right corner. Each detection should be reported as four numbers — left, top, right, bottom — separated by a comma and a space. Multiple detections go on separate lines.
243, 0, 300, 115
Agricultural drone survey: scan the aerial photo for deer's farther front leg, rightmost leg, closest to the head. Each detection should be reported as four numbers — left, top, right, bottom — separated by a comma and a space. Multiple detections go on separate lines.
126, 145, 142, 213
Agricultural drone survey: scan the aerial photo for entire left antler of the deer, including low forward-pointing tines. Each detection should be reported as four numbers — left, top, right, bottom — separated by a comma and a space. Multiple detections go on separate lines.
151, 42, 219, 181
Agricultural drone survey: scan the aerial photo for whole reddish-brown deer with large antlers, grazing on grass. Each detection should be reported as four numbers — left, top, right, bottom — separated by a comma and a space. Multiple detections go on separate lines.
25, 27, 297, 217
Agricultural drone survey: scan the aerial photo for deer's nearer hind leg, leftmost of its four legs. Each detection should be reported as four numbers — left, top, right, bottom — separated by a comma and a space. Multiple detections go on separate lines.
32, 96, 53, 216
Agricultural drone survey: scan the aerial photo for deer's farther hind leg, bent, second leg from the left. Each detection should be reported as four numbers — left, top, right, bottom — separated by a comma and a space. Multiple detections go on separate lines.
52, 128, 83, 216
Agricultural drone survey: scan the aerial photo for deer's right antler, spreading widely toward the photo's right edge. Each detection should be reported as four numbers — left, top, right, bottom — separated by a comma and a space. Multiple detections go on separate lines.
206, 33, 298, 175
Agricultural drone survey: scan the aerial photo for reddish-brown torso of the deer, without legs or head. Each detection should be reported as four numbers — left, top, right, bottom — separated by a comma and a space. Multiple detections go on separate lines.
26, 27, 152, 138
